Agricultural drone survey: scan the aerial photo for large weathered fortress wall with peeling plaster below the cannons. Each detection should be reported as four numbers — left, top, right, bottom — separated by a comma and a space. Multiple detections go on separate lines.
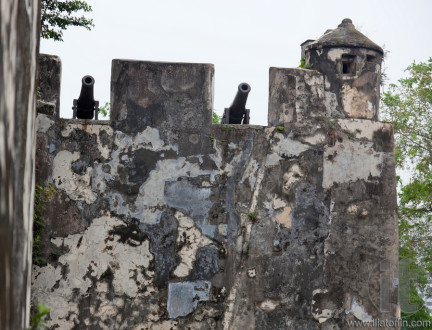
33, 60, 397, 330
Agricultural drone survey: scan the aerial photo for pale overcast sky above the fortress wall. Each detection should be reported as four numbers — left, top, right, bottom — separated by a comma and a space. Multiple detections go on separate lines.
41, 0, 432, 125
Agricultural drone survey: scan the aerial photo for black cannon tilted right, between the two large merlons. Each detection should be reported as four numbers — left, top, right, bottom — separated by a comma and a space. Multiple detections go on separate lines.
221, 83, 251, 124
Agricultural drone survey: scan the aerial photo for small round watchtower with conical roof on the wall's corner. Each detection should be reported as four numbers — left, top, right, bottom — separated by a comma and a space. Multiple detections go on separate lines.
303, 18, 383, 120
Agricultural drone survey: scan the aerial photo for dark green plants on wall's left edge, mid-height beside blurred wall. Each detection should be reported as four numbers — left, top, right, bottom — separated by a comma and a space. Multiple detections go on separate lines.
33, 185, 56, 265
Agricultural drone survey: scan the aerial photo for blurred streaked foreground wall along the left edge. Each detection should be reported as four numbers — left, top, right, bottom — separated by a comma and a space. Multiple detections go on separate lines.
0, 0, 39, 330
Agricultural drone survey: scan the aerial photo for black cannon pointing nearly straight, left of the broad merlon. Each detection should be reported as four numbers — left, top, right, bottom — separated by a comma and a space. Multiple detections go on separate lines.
72, 76, 99, 120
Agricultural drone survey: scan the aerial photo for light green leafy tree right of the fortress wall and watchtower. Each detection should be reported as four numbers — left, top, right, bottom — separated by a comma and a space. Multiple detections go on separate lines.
382, 58, 432, 320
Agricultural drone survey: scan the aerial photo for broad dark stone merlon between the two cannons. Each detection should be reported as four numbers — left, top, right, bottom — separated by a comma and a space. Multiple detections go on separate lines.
111, 59, 214, 132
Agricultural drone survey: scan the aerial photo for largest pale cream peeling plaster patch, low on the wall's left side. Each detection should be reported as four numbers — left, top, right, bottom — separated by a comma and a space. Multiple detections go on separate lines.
32, 216, 159, 329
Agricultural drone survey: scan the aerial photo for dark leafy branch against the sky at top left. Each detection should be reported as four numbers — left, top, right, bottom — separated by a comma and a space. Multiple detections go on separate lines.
41, 0, 94, 41
